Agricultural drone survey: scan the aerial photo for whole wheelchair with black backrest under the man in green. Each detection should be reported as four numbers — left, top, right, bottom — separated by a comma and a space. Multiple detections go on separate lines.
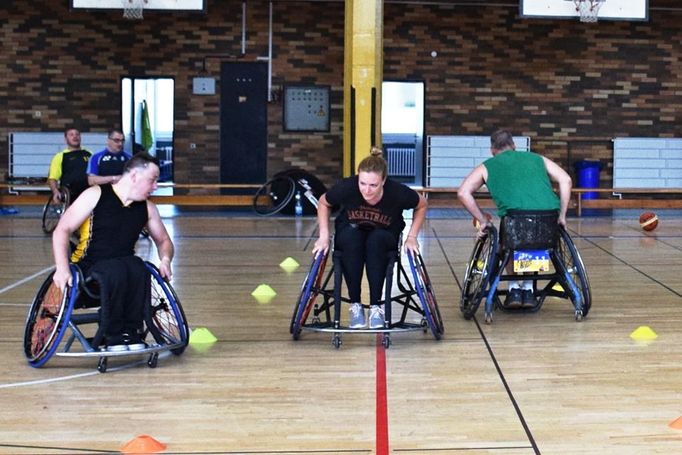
460, 210, 592, 324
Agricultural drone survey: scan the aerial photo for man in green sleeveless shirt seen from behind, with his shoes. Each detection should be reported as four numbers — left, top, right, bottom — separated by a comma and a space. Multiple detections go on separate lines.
457, 126, 572, 308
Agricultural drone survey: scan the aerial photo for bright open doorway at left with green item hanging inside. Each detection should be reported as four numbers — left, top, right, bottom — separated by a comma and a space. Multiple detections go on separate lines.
121, 77, 175, 182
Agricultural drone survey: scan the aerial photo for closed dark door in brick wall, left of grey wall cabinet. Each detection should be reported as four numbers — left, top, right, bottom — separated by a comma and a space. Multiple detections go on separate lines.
220, 62, 268, 188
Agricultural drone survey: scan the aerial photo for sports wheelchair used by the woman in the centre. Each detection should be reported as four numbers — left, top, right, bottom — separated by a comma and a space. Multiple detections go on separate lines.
289, 242, 444, 349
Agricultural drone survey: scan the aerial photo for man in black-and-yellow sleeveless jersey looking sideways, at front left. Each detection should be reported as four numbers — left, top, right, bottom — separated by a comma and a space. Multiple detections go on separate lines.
52, 153, 174, 351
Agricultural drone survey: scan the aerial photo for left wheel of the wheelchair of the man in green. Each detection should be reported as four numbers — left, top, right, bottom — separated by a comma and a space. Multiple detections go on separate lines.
459, 225, 497, 319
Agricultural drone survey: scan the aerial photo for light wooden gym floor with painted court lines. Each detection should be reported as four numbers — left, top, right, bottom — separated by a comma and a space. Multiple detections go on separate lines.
0, 207, 682, 455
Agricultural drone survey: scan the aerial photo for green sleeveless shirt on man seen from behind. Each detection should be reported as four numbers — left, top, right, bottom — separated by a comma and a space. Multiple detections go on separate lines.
483, 150, 560, 217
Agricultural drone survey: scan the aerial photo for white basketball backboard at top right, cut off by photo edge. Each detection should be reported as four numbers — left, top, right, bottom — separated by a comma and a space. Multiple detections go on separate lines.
519, 0, 649, 21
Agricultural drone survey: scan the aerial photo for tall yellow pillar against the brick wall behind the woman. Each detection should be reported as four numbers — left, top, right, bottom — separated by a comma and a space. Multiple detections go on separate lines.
343, 0, 384, 177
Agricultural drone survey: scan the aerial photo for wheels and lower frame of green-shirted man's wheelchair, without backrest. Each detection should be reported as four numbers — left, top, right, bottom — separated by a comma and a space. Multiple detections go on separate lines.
460, 216, 592, 324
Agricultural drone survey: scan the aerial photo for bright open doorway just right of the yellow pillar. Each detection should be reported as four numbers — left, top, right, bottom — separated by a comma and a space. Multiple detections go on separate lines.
381, 81, 425, 186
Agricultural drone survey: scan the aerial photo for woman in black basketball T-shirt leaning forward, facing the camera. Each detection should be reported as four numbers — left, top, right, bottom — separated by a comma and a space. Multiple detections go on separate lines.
313, 147, 427, 329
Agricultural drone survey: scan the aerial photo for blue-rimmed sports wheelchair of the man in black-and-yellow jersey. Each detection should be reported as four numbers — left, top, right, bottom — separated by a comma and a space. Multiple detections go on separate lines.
24, 262, 189, 373
